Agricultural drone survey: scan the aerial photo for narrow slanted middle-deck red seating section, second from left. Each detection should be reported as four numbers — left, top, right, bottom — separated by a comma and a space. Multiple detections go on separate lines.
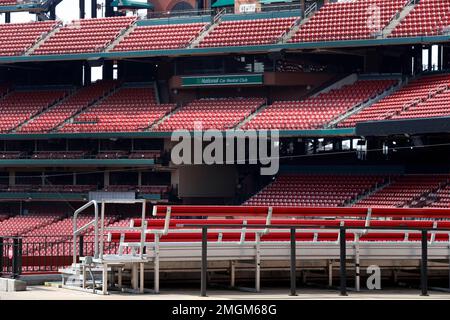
19, 80, 118, 133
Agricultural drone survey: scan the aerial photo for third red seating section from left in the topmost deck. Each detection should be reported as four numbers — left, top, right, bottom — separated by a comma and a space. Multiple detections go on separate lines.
112, 23, 206, 51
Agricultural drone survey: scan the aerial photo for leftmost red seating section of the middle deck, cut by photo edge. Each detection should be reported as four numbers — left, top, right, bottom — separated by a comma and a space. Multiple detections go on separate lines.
0, 89, 67, 133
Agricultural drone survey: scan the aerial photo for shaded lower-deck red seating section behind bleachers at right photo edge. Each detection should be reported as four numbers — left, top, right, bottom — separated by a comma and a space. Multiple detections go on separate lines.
354, 175, 450, 208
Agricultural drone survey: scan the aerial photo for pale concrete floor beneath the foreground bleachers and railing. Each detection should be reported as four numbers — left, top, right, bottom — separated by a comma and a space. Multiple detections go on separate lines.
0, 286, 450, 300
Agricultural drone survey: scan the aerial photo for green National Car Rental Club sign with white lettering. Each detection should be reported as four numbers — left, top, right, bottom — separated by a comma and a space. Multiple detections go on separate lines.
181, 74, 263, 87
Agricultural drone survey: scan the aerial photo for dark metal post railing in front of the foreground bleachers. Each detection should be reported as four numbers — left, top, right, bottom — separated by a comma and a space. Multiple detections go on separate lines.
178, 224, 450, 297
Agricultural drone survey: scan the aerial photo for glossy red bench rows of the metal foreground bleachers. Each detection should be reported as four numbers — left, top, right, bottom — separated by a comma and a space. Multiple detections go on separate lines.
108, 206, 450, 243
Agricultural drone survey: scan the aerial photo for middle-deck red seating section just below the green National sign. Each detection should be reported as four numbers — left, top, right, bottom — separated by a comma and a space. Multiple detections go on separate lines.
154, 98, 265, 131
